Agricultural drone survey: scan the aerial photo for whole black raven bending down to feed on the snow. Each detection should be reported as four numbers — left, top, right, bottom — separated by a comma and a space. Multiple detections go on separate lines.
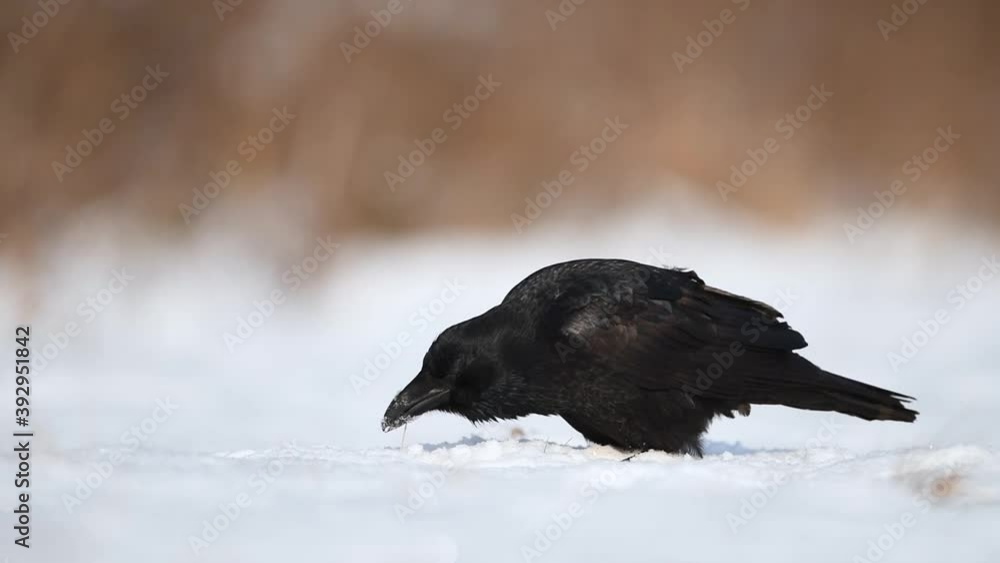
382, 259, 917, 456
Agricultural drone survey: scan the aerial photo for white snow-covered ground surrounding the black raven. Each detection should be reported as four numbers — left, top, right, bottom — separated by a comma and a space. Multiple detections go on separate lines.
0, 200, 1000, 563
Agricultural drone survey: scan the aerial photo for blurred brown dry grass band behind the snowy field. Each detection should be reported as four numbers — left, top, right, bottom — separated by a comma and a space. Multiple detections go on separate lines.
0, 0, 1000, 251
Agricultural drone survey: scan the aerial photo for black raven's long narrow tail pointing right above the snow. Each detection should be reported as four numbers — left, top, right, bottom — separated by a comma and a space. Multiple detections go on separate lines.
748, 357, 919, 422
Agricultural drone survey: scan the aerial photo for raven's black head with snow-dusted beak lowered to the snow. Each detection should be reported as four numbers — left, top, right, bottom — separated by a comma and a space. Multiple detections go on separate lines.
382, 317, 547, 432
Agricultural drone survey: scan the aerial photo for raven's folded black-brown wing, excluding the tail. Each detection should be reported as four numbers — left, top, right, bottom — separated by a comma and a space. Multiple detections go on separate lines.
538, 261, 809, 401
